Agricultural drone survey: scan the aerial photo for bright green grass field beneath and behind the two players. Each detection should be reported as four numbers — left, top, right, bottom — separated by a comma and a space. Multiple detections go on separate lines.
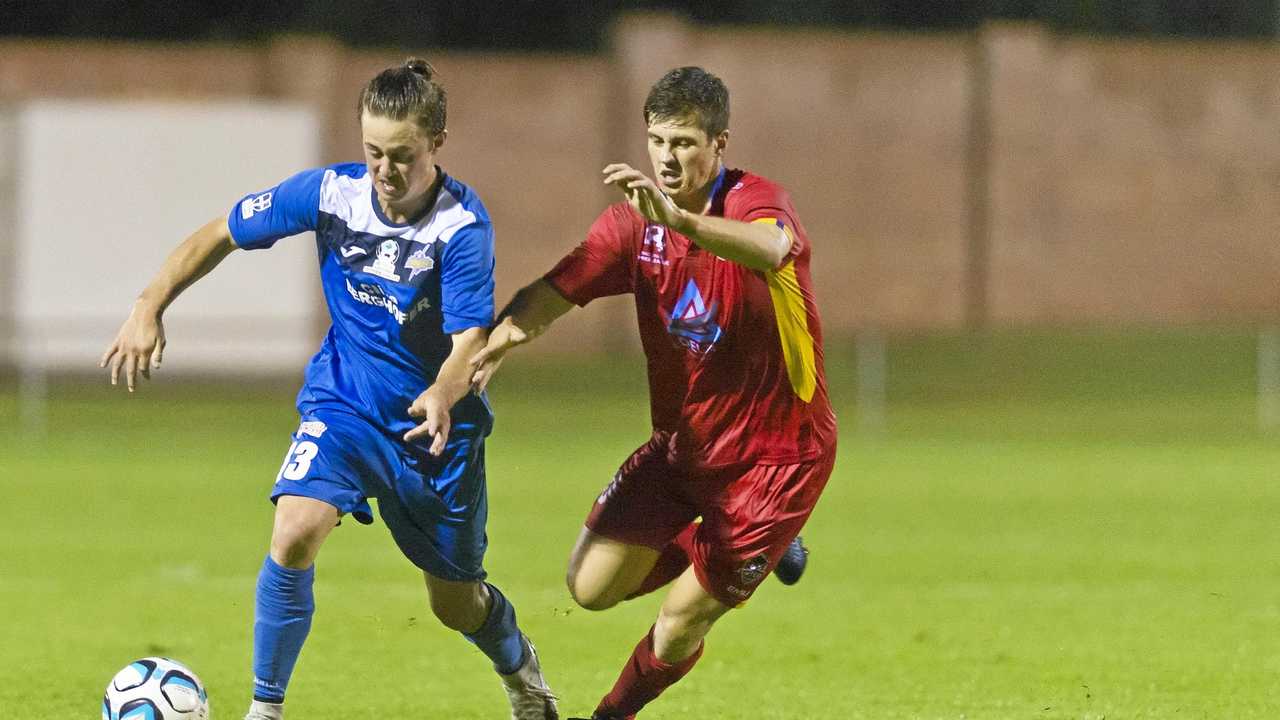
0, 331, 1280, 720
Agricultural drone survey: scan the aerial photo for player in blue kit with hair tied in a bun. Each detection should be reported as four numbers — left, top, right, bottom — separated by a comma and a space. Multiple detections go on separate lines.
101, 59, 557, 720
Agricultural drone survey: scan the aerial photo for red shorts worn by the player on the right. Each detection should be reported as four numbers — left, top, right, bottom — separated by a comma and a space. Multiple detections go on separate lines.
586, 437, 836, 607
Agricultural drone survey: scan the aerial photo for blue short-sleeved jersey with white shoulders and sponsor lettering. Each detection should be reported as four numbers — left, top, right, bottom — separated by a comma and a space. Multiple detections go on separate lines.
227, 163, 494, 437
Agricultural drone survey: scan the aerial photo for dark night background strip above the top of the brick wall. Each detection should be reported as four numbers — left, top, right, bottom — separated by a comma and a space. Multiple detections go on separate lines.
0, 0, 1280, 51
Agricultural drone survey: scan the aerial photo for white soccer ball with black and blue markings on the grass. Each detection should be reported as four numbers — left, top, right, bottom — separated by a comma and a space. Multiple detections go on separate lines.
102, 657, 209, 720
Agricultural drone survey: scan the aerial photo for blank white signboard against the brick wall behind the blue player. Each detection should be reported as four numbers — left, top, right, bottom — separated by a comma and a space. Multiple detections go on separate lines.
11, 101, 325, 374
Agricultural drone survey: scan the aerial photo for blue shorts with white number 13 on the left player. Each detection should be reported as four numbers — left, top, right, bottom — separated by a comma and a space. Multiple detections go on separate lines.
271, 407, 489, 580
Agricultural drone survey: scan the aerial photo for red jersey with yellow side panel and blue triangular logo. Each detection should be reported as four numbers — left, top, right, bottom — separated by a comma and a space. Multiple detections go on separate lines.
545, 170, 836, 468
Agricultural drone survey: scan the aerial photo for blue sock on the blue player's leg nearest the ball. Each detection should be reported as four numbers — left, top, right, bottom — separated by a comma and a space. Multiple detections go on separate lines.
253, 555, 316, 702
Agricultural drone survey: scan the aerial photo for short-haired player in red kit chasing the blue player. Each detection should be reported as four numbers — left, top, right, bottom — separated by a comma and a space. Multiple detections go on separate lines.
472, 68, 836, 720
